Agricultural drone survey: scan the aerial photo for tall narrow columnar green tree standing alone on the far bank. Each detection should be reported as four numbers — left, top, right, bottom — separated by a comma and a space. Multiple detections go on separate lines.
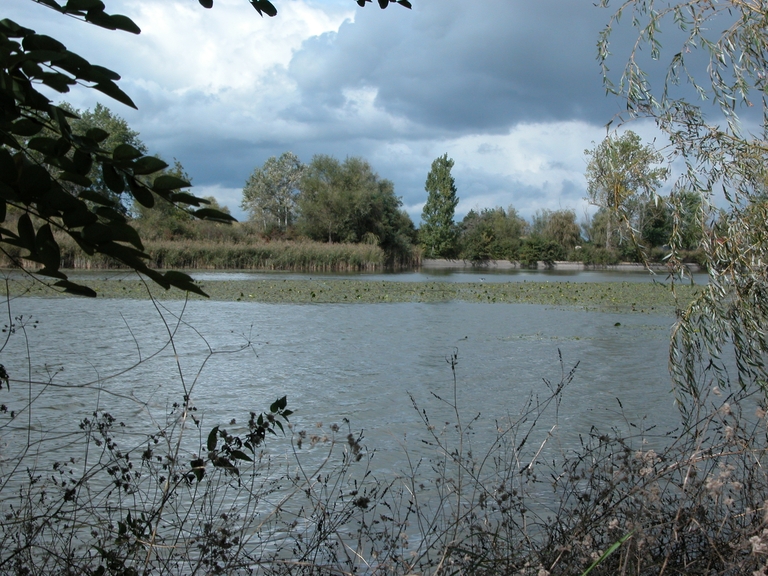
420, 154, 459, 258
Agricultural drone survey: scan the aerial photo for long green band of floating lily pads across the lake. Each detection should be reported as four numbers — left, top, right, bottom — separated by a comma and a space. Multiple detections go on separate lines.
2, 278, 697, 313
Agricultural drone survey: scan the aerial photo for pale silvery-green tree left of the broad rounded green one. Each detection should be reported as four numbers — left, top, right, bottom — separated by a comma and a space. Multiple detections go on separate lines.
242, 152, 305, 231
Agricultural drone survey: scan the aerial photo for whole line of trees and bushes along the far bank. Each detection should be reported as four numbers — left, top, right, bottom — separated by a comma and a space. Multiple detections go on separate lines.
11, 98, 704, 266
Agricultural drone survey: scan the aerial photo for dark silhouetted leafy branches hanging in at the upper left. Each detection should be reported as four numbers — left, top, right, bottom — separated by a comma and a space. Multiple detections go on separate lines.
0, 7, 231, 296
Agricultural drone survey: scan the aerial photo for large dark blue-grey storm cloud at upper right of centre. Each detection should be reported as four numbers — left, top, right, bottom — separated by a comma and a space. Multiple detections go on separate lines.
289, 0, 617, 133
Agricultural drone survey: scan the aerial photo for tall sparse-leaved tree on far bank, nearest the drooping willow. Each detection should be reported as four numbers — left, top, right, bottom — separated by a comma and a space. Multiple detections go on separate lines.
584, 130, 669, 248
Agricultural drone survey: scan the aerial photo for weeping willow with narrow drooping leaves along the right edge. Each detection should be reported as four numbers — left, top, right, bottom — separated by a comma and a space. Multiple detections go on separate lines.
598, 0, 768, 402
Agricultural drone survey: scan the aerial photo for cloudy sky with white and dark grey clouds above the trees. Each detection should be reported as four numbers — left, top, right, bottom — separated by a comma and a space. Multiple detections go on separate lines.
6, 0, 668, 225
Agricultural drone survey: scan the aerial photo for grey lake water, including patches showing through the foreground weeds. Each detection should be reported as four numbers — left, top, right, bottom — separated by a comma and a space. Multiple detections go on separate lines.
0, 272, 696, 573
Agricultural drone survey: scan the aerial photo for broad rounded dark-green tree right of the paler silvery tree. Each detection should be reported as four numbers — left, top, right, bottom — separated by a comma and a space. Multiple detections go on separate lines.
297, 154, 413, 258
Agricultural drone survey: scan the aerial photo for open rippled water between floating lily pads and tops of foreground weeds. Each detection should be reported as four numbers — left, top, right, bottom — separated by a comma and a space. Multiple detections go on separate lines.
2, 298, 676, 466
